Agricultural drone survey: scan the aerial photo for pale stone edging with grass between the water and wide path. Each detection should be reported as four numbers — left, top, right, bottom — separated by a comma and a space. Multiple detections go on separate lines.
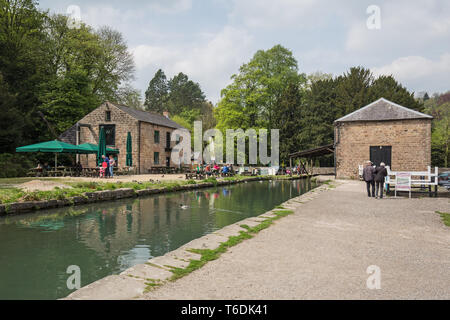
61, 176, 339, 300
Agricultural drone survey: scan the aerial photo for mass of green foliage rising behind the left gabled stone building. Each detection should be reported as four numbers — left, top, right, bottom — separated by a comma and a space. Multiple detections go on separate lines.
0, 0, 139, 170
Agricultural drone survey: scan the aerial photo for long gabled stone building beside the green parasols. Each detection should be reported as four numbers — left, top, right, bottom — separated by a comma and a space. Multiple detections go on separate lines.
60, 101, 185, 173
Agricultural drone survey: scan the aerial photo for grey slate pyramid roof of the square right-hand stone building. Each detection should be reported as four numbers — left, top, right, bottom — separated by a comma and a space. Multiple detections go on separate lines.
334, 98, 433, 122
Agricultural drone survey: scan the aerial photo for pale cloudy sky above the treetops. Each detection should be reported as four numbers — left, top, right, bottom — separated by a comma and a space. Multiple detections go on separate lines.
39, 0, 450, 103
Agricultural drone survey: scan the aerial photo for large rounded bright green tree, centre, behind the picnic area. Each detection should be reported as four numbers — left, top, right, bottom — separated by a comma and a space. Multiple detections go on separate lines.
216, 45, 306, 129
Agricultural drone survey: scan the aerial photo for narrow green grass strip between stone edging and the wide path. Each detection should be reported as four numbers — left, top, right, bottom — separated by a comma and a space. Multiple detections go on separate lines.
169, 210, 293, 281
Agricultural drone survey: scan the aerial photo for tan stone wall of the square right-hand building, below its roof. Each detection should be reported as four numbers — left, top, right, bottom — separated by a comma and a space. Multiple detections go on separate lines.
335, 119, 431, 179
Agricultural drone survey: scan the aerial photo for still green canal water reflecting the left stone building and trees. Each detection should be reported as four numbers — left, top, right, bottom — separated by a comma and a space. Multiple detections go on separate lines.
0, 179, 315, 299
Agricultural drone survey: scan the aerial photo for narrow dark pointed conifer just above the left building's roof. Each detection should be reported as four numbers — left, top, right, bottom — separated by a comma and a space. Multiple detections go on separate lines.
144, 69, 169, 113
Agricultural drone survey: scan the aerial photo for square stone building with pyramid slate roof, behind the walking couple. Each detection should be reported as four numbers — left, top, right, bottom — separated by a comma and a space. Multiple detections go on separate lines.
334, 98, 433, 179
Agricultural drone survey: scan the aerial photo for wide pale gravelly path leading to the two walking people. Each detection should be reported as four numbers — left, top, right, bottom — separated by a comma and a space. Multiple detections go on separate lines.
141, 181, 450, 300
